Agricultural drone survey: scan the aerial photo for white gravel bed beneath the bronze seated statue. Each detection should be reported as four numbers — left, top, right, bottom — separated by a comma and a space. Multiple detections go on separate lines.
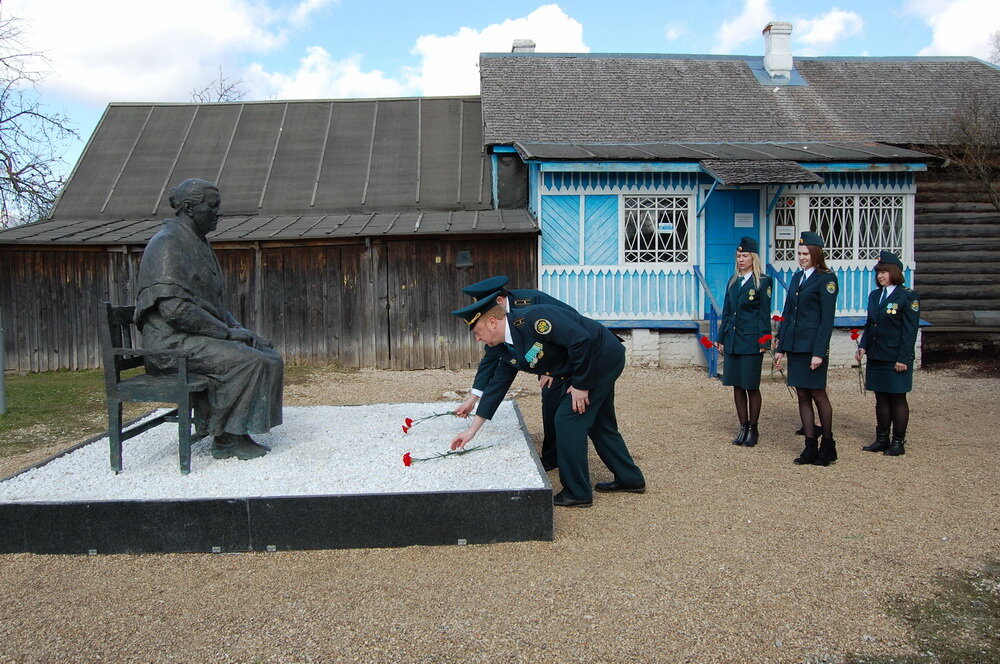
0, 401, 548, 503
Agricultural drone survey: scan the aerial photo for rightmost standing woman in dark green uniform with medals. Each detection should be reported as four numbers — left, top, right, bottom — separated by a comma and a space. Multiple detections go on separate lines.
856, 251, 920, 456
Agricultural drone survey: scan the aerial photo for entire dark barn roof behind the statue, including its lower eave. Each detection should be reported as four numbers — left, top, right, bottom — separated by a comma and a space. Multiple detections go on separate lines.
0, 97, 538, 245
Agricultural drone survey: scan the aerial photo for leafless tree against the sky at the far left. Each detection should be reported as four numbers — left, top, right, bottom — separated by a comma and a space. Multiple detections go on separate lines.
0, 7, 77, 228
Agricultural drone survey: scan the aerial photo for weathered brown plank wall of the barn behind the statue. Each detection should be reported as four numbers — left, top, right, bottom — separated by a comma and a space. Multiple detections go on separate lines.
0, 236, 537, 371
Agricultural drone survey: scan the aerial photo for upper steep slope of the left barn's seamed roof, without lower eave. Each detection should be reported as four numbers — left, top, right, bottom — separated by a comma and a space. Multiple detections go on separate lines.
52, 97, 491, 221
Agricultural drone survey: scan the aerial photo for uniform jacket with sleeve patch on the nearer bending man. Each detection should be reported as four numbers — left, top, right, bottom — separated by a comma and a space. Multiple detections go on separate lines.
476, 304, 625, 419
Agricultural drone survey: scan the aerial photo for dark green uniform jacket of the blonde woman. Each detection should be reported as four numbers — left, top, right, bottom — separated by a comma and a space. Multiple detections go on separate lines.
719, 276, 772, 355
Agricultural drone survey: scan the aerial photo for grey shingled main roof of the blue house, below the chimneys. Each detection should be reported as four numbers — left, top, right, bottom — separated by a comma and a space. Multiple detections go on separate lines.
480, 53, 1000, 145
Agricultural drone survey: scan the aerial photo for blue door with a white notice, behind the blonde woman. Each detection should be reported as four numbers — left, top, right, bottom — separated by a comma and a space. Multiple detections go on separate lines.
705, 189, 763, 313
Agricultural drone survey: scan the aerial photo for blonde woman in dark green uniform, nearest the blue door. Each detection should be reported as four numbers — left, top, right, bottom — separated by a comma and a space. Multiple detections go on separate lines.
715, 237, 771, 447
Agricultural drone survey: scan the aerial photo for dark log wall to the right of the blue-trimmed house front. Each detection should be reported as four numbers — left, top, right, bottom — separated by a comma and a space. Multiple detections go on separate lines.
913, 165, 1000, 331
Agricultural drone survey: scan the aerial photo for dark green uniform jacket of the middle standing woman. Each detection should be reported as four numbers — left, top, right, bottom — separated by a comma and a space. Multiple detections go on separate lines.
777, 269, 840, 357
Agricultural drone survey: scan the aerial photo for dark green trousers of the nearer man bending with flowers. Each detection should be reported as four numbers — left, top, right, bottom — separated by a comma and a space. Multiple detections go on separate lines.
555, 352, 645, 500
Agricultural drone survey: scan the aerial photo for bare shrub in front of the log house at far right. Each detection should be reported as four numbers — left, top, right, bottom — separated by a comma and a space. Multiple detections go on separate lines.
941, 88, 1000, 210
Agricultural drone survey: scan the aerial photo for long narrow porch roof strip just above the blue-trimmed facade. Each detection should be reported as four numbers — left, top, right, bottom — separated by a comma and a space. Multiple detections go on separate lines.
514, 141, 940, 163
